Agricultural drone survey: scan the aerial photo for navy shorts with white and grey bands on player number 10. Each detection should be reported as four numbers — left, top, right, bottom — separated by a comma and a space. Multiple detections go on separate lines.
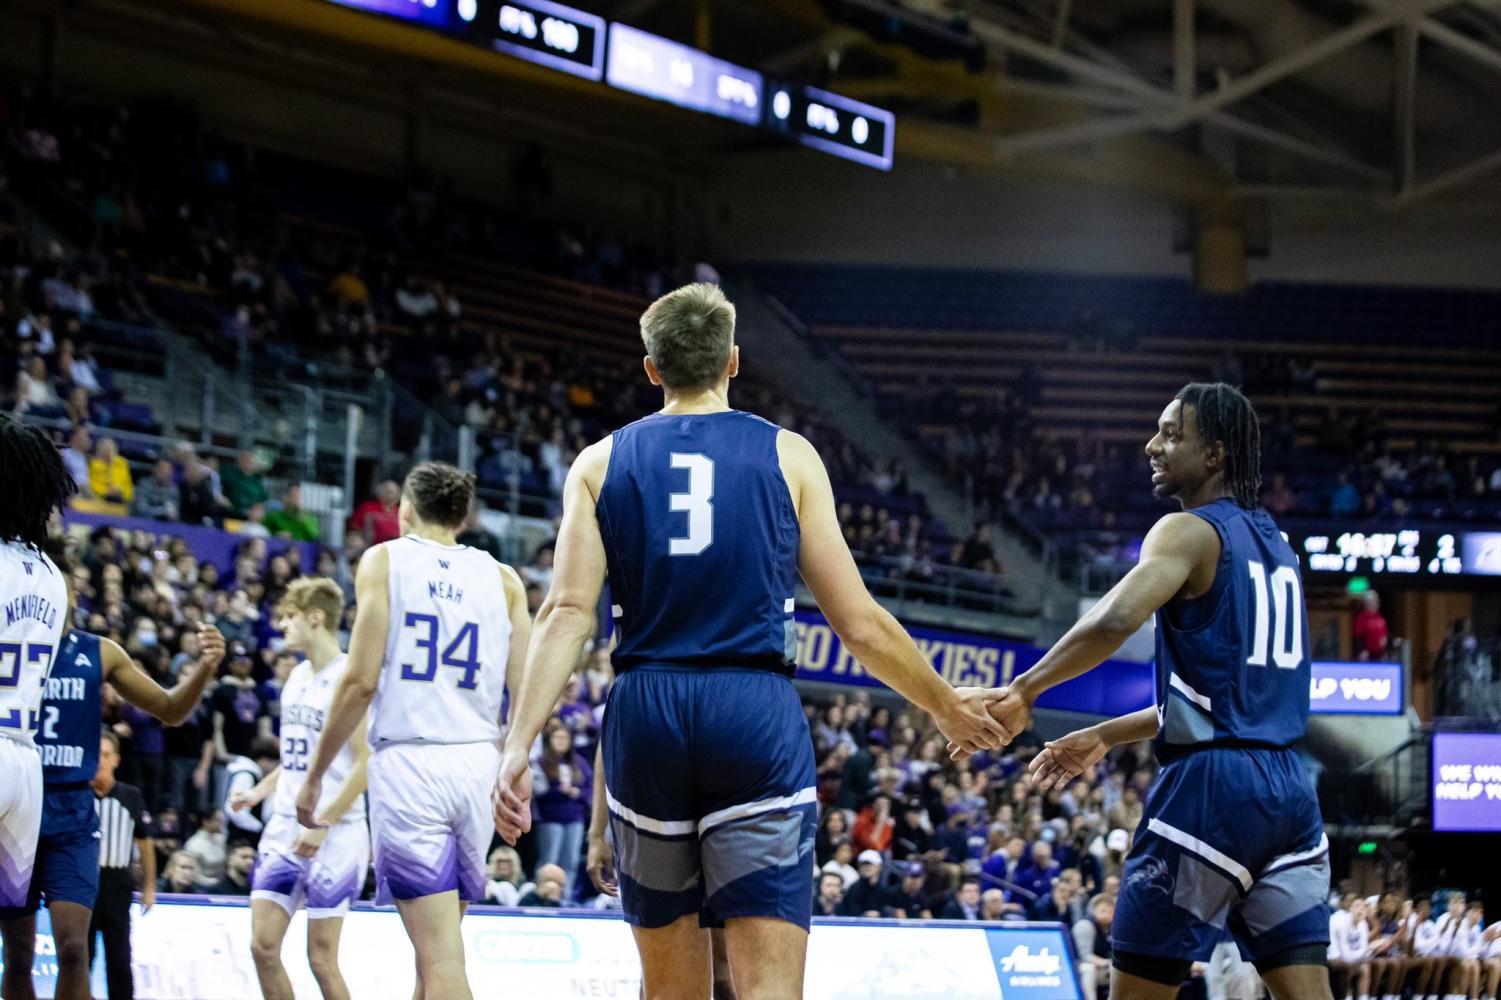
1111, 748, 1328, 961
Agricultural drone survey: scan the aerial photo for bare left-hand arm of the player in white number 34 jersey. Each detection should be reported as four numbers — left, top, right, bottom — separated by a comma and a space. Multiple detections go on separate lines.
297, 545, 390, 827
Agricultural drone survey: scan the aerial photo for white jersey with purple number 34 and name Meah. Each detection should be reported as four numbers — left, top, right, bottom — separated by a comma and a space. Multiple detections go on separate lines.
371, 535, 510, 746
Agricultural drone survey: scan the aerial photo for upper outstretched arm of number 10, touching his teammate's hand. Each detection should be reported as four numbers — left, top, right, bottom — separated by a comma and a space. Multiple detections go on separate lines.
1001, 514, 1219, 717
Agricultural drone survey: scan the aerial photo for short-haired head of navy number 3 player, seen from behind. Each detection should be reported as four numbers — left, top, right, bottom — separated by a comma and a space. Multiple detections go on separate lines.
641, 282, 735, 392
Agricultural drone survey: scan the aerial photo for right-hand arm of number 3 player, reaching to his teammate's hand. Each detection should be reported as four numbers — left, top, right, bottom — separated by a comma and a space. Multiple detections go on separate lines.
776, 431, 1015, 751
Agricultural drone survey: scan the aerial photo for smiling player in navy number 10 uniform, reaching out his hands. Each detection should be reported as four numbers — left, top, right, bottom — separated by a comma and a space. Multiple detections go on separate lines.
997, 383, 1330, 1000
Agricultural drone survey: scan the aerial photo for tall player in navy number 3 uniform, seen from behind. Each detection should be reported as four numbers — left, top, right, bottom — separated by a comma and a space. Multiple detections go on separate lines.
494, 284, 1007, 1000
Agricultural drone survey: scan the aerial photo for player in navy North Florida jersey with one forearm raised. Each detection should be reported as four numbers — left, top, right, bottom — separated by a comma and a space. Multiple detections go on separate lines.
0, 551, 224, 1000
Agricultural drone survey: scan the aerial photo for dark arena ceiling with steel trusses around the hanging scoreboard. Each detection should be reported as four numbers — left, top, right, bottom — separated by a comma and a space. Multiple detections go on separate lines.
17, 0, 1501, 209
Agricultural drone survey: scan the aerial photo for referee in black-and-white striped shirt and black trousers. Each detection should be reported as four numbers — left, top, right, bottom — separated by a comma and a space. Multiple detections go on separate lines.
89, 728, 156, 1000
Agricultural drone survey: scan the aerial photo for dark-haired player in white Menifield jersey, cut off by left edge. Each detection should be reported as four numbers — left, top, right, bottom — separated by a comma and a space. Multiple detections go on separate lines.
0, 416, 75, 908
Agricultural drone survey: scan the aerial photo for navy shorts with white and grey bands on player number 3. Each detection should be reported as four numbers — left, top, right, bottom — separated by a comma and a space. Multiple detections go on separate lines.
602, 665, 818, 928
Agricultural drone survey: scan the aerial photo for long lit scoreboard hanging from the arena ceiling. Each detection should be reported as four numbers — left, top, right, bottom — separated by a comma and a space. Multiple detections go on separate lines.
327, 0, 896, 170
